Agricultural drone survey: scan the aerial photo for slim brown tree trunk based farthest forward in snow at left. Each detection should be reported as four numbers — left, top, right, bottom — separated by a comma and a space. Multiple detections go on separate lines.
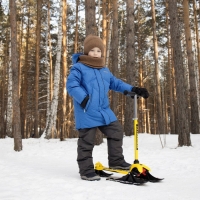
10, 0, 22, 151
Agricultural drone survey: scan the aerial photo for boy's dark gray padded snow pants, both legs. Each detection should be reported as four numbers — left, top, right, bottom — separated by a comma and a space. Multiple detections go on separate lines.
77, 121, 124, 176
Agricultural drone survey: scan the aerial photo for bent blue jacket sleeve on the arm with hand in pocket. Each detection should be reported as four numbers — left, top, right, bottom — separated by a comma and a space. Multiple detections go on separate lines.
66, 65, 87, 104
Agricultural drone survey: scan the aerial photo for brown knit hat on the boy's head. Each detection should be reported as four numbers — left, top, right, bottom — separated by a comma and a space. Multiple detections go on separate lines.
83, 35, 104, 57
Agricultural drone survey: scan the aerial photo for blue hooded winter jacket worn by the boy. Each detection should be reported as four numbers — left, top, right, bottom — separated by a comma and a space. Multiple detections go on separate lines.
66, 54, 133, 129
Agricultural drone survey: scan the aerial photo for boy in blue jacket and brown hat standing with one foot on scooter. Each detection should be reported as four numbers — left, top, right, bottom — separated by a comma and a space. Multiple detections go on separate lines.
67, 35, 149, 181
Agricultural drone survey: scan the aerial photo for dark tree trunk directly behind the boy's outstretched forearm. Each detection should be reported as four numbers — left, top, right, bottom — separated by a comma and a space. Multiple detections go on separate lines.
124, 0, 136, 136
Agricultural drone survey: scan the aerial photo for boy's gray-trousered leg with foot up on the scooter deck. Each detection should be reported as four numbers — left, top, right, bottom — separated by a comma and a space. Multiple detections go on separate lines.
98, 121, 124, 166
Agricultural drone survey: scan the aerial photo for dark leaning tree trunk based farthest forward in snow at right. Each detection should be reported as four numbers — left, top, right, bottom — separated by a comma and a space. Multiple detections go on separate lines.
169, 0, 191, 146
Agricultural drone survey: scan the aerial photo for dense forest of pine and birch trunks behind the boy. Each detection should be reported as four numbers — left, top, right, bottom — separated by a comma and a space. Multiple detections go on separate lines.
0, 0, 200, 151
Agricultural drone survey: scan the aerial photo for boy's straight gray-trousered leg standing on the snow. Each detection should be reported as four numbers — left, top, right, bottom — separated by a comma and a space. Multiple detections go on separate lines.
77, 128, 96, 175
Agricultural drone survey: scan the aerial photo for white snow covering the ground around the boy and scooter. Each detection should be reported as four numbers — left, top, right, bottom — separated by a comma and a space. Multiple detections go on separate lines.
0, 134, 200, 200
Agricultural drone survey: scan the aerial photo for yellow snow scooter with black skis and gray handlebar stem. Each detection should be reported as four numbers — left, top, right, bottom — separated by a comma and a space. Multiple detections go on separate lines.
95, 91, 163, 185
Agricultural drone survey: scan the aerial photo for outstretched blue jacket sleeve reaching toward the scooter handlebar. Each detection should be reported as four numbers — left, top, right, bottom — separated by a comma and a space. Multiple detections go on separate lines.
110, 72, 133, 93
